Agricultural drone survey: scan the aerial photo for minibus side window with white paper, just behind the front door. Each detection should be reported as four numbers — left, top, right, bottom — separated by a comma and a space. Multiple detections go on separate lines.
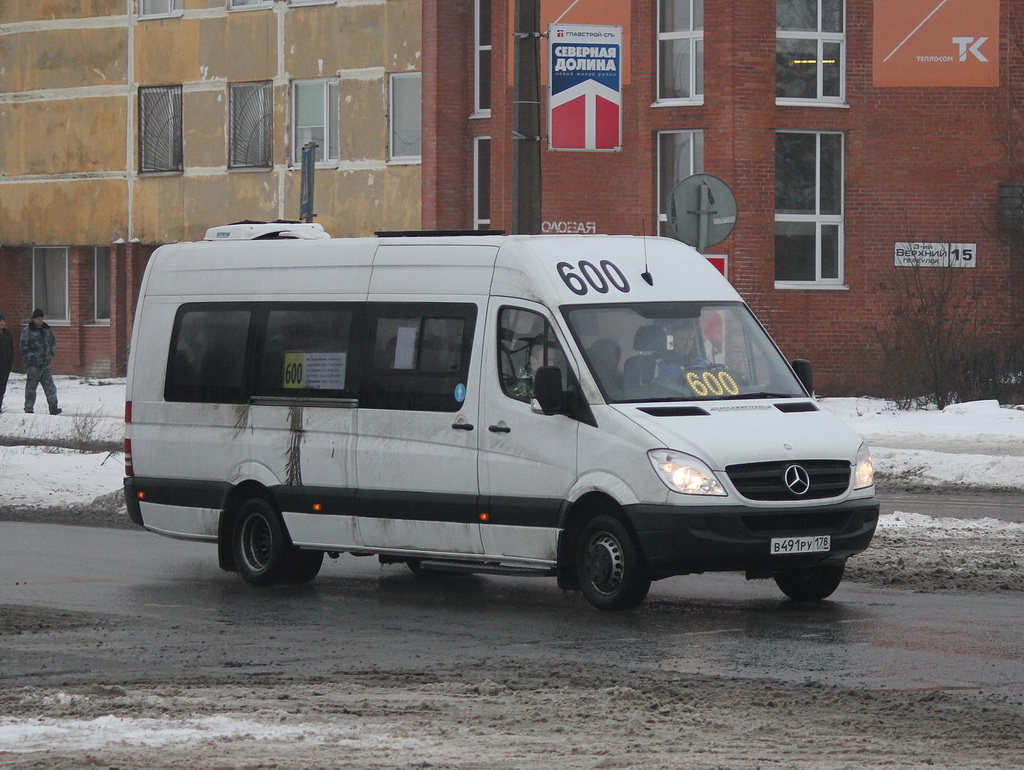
359, 303, 476, 412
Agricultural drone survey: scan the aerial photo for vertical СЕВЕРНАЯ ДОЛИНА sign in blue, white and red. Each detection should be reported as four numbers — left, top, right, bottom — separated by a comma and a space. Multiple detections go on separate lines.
548, 24, 623, 152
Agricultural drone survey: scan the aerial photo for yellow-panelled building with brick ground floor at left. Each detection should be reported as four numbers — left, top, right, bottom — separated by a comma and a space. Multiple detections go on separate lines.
0, 0, 421, 376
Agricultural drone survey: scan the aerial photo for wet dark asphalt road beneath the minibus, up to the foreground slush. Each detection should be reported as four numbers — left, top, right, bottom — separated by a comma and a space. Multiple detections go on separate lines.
0, 522, 1024, 711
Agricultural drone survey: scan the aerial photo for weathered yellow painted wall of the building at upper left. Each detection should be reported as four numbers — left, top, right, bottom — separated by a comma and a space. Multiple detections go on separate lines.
0, 0, 421, 246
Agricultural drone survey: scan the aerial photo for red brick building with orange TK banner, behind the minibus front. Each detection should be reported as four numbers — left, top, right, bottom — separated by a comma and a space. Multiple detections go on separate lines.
423, 0, 1024, 394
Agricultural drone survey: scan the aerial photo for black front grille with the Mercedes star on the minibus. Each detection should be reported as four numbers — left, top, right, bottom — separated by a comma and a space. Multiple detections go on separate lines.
725, 460, 853, 501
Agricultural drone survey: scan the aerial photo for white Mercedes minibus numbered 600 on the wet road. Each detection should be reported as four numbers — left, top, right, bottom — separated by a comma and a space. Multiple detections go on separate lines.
125, 223, 879, 609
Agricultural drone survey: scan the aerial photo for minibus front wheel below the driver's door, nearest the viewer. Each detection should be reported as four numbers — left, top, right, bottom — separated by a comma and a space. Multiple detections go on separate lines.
575, 515, 650, 609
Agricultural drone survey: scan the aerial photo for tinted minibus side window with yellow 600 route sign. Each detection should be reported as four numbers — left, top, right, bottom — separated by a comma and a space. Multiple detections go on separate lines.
254, 304, 355, 398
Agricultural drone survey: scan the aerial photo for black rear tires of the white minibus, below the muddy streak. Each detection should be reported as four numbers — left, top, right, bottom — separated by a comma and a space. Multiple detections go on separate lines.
231, 498, 324, 586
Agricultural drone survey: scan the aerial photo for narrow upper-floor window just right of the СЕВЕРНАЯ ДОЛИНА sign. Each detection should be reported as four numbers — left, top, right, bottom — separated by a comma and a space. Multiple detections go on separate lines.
657, 0, 703, 101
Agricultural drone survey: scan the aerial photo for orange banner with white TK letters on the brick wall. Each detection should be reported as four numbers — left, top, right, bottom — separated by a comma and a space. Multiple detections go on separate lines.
873, 0, 999, 88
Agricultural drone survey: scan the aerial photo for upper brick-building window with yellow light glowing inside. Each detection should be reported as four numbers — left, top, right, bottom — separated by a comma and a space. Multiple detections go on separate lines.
775, 0, 846, 103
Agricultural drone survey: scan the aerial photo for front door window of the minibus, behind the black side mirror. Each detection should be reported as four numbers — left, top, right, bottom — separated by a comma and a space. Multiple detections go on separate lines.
498, 307, 568, 402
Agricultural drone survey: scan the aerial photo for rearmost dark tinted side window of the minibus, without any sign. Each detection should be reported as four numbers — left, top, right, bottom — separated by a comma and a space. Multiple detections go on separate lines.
164, 305, 252, 403
